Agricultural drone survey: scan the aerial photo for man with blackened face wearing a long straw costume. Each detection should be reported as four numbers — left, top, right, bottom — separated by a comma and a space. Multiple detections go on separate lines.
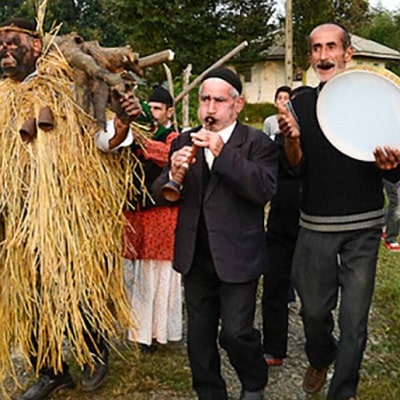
0, 19, 140, 400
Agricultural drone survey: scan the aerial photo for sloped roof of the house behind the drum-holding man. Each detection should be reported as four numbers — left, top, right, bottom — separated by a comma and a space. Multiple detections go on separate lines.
263, 34, 400, 60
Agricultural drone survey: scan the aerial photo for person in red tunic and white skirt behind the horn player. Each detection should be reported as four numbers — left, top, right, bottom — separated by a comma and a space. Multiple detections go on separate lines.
124, 87, 182, 351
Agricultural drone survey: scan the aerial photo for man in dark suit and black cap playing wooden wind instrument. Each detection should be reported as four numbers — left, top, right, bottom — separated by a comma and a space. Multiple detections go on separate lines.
153, 68, 277, 400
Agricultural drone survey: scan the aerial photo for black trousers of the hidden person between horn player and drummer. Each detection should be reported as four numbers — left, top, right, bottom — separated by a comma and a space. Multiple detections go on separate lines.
262, 234, 296, 358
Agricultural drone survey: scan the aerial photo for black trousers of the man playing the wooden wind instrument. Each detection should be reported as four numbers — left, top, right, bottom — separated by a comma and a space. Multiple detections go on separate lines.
184, 260, 268, 400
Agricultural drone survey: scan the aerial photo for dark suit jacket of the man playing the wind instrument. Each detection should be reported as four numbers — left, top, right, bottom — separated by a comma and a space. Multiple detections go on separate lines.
153, 122, 278, 283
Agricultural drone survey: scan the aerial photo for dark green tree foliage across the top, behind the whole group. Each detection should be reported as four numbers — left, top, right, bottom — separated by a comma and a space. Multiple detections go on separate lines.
0, 0, 400, 90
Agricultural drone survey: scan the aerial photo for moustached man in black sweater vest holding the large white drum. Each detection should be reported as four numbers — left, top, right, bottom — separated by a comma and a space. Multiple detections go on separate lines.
278, 23, 400, 400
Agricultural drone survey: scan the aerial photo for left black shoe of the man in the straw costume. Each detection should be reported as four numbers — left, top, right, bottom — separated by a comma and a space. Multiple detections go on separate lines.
18, 373, 75, 400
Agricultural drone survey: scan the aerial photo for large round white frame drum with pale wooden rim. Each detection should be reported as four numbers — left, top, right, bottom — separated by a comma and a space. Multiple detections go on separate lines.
317, 67, 400, 161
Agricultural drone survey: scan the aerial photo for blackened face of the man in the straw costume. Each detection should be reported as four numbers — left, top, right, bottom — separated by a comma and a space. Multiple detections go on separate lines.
0, 31, 41, 81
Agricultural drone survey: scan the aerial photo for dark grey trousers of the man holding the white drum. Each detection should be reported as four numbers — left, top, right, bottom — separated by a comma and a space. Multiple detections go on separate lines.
293, 228, 381, 400
